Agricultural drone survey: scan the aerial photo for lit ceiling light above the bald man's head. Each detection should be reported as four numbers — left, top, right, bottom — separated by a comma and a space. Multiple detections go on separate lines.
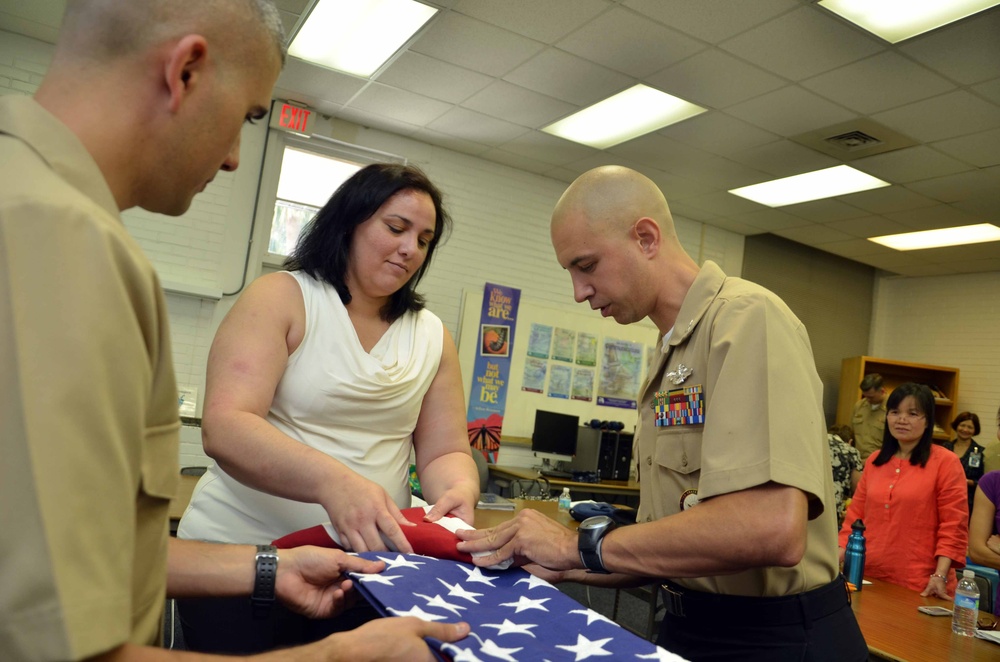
542, 84, 707, 149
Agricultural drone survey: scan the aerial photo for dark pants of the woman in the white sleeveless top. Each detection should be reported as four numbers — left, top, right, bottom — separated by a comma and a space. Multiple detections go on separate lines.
177, 598, 378, 655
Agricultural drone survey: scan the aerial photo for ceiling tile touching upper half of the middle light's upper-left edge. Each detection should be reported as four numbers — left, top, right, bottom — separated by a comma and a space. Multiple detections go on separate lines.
503, 48, 636, 107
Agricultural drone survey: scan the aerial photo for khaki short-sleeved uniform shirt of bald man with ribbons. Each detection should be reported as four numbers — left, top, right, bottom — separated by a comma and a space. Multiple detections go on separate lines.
635, 262, 838, 596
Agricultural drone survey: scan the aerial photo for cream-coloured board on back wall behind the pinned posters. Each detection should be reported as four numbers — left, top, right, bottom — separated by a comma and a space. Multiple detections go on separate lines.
457, 289, 659, 438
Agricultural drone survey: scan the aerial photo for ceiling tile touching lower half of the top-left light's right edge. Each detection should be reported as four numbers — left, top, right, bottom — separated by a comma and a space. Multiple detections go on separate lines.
378, 51, 495, 103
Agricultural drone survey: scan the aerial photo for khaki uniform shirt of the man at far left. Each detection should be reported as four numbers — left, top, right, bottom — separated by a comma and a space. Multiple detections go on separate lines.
0, 97, 180, 660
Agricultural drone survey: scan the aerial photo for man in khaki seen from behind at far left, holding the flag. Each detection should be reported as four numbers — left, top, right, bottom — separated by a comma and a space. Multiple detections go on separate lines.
0, 0, 466, 661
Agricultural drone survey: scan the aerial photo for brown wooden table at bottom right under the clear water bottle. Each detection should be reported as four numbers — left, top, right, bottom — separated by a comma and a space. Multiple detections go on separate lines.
851, 579, 1000, 662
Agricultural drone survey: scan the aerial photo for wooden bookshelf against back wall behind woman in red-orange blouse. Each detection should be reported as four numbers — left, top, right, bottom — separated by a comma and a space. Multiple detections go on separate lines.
837, 356, 958, 441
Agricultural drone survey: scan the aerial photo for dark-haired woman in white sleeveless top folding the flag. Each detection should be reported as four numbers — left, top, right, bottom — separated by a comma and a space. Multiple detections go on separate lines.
178, 164, 479, 652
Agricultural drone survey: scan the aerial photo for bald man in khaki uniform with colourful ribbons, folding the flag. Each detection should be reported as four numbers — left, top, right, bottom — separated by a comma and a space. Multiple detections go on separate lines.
459, 166, 868, 662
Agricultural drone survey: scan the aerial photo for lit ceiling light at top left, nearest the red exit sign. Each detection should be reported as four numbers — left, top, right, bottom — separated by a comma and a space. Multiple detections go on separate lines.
288, 0, 437, 78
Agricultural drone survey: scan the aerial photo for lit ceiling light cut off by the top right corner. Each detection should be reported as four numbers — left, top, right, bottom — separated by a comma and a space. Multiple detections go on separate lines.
819, 0, 1000, 44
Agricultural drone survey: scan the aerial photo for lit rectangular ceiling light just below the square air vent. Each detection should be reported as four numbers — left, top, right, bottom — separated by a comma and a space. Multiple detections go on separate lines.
729, 166, 890, 207
